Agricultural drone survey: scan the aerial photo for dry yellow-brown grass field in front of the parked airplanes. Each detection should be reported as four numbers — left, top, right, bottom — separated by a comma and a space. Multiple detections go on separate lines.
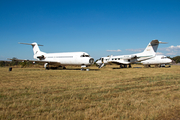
0, 65, 180, 120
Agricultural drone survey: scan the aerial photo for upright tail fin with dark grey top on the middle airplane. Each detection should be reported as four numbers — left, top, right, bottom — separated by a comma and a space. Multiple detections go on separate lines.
143, 40, 160, 55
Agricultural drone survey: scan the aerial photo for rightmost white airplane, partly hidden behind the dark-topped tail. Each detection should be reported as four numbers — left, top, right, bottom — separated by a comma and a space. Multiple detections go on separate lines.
141, 55, 172, 67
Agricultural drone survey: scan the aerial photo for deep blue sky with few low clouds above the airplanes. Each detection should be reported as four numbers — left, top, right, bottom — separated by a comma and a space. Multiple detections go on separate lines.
0, 0, 180, 60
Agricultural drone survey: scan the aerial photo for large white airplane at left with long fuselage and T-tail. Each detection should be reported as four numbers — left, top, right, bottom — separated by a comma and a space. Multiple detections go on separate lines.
11, 42, 94, 70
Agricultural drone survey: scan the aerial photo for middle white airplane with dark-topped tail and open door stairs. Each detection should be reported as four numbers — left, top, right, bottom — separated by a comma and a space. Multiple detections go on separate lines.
96, 40, 164, 68
